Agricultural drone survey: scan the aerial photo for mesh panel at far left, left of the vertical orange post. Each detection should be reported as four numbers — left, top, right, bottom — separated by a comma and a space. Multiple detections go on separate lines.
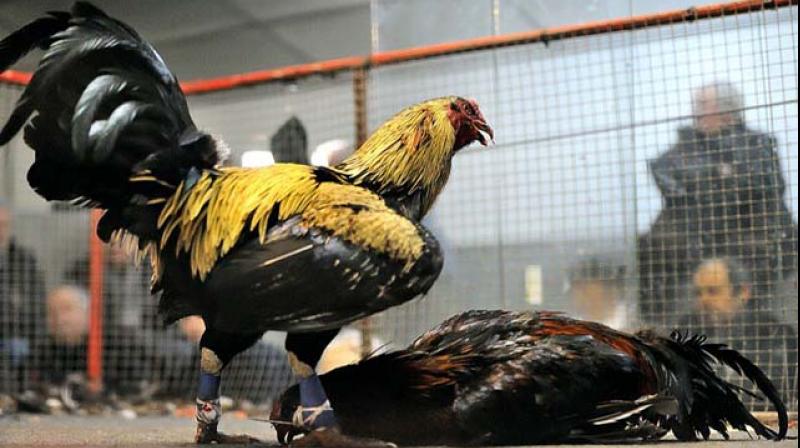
0, 82, 94, 393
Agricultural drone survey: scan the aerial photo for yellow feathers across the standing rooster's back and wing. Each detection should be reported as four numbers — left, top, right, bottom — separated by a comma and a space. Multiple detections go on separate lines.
152, 164, 423, 280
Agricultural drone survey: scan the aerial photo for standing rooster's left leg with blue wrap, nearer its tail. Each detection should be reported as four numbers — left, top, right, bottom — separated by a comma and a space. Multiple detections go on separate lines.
195, 328, 261, 443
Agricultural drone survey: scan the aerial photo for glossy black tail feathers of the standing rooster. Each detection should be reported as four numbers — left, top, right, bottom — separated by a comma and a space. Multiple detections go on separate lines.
0, 2, 224, 238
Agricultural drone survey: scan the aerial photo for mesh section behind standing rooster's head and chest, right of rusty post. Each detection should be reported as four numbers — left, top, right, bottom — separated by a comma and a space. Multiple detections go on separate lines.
367, 52, 503, 346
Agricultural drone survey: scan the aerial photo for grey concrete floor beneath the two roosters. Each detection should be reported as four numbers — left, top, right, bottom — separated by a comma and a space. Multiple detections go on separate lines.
0, 414, 797, 448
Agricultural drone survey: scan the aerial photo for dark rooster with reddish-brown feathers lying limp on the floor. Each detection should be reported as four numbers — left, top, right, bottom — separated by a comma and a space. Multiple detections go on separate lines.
271, 311, 787, 446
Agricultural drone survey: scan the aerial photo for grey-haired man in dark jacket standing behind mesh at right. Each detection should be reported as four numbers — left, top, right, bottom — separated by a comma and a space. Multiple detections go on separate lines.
639, 82, 797, 318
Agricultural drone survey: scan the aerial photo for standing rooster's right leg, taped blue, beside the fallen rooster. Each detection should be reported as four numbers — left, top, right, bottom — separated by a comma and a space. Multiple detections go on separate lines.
286, 328, 339, 430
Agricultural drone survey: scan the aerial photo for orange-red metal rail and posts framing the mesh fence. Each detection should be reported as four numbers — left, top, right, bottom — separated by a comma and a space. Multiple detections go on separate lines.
0, 0, 798, 410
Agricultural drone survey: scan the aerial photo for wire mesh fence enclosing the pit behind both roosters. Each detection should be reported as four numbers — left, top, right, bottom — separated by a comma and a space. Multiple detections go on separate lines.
0, 0, 798, 410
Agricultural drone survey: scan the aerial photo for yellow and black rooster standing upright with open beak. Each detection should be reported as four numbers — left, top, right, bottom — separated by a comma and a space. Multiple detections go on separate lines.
0, 2, 492, 445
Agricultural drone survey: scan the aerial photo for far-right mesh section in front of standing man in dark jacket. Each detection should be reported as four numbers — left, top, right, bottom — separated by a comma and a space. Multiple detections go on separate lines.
630, 8, 797, 406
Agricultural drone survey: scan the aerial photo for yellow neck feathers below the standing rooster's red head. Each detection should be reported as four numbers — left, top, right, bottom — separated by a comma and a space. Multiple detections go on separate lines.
337, 97, 456, 214
